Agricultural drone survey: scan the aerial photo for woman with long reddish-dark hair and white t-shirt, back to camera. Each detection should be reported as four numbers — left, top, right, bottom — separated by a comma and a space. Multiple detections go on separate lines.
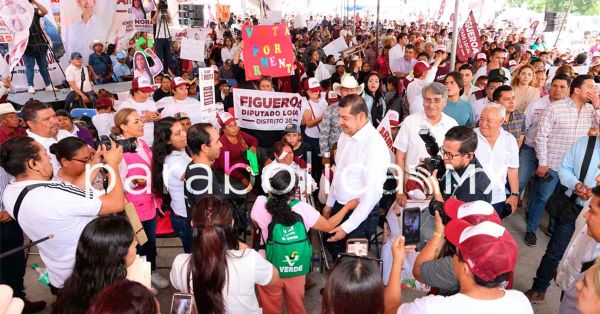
171, 196, 279, 314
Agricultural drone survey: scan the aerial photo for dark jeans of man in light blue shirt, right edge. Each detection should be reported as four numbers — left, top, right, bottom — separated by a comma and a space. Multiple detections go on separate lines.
531, 219, 575, 293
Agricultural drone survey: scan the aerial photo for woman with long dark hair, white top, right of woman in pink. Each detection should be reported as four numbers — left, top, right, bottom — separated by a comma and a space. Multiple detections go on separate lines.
152, 117, 192, 253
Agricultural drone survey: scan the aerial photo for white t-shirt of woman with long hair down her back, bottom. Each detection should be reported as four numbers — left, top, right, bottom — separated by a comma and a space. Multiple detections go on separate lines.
171, 248, 273, 314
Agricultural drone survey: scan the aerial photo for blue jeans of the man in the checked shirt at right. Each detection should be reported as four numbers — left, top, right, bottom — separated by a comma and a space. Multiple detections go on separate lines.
527, 169, 559, 232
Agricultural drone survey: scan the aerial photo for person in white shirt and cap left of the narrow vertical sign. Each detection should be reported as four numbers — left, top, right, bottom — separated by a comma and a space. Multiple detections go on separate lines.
156, 77, 204, 124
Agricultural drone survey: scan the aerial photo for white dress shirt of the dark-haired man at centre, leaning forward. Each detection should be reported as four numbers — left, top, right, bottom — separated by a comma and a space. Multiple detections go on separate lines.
327, 123, 390, 233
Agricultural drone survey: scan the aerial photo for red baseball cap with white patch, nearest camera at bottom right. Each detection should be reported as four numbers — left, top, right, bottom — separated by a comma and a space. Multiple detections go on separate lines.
445, 219, 518, 281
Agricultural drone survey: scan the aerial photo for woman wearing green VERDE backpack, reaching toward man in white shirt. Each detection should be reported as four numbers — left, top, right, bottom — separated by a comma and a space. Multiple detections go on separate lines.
250, 170, 358, 314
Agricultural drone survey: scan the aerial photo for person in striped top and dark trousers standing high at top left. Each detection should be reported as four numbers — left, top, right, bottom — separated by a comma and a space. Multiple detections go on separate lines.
152, 0, 171, 73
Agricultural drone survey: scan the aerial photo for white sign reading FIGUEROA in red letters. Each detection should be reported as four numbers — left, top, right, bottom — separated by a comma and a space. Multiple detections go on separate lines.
233, 88, 304, 131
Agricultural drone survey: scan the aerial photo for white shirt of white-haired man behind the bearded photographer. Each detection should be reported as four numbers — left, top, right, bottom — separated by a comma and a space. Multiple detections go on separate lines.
475, 128, 519, 204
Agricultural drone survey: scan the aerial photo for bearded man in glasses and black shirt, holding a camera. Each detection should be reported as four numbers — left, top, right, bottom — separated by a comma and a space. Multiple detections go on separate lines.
431, 126, 492, 203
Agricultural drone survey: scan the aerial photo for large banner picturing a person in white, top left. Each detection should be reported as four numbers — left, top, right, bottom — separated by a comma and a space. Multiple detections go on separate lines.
60, 0, 135, 64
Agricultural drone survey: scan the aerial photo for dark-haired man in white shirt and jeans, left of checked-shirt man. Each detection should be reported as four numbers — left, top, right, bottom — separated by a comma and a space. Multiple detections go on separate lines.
519, 75, 571, 193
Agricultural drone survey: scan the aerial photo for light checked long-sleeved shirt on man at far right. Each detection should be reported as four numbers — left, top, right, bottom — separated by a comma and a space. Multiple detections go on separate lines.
535, 97, 600, 170
